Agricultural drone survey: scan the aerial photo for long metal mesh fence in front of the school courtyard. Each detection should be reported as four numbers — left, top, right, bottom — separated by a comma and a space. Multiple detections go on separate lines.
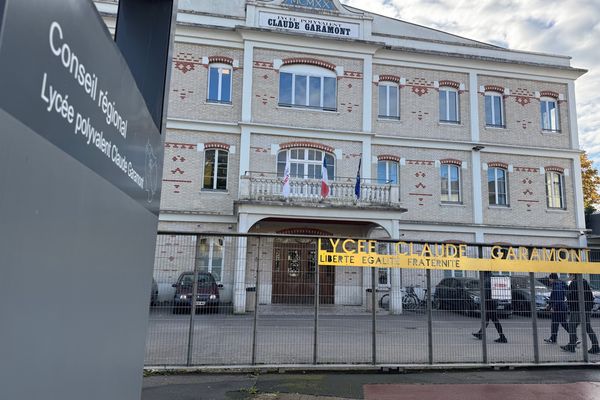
145, 234, 600, 366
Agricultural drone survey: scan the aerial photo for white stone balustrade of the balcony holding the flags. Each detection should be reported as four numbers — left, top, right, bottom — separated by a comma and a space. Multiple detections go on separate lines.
240, 175, 400, 206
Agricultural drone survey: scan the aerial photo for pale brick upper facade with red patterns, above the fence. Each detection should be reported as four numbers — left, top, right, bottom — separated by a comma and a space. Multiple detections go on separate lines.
97, 0, 586, 311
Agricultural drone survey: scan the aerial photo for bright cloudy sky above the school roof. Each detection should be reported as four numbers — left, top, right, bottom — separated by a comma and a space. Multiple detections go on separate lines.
341, 0, 600, 168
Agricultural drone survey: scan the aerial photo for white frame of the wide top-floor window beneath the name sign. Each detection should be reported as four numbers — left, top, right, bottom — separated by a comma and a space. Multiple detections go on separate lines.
277, 64, 338, 112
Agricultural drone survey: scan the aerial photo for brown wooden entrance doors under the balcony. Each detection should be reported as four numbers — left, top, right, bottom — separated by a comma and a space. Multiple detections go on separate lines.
271, 239, 335, 304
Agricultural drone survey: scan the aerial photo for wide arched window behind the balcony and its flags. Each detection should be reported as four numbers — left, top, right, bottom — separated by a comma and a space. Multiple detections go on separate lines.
277, 149, 335, 180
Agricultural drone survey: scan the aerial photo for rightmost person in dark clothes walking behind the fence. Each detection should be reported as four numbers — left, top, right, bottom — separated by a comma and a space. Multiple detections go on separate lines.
561, 274, 600, 354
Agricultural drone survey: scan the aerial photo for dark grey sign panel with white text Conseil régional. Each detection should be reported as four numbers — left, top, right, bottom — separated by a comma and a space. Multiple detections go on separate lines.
0, 0, 162, 215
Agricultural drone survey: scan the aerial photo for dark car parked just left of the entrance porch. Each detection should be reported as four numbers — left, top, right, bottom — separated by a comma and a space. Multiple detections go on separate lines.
173, 272, 219, 314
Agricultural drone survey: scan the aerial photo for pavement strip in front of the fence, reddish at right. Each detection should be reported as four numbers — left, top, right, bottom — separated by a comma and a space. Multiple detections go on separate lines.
142, 367, 600, 400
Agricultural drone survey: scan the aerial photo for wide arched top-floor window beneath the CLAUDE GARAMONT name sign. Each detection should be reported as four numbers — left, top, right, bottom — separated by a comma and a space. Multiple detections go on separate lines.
279, 65, 337, 111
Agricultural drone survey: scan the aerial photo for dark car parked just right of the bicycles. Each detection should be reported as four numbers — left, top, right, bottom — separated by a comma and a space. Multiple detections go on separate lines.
433, 278, 512, 316
